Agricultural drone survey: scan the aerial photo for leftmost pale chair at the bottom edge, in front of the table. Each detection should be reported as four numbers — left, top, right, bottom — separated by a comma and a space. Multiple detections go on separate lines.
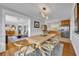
15, 44, 35, 56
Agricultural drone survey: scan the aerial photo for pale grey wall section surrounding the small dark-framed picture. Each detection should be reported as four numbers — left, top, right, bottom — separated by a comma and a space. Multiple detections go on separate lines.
30, 17, 45, 36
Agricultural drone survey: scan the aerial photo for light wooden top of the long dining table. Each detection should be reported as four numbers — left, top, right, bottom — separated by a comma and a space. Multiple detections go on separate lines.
27, 34, 57, 45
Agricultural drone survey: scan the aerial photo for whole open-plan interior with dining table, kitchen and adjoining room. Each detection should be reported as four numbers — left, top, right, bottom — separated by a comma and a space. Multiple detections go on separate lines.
0, 3, 79, 56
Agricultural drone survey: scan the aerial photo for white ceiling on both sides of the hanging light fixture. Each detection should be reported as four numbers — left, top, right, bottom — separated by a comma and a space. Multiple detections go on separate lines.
0, 3, 73, 20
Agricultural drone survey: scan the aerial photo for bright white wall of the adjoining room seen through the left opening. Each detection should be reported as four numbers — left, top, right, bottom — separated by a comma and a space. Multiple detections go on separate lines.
5, 14, 28, 35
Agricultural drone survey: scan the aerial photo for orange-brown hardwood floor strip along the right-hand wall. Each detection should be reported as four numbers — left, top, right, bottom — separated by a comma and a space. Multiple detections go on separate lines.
60, 38, 76, 56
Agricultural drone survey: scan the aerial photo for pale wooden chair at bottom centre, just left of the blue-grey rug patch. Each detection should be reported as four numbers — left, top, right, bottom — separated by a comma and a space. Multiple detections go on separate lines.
38, 42, 52, 56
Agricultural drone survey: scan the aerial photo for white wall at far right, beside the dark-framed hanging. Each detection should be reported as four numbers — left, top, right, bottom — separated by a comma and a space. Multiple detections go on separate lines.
70, 4, 79, 56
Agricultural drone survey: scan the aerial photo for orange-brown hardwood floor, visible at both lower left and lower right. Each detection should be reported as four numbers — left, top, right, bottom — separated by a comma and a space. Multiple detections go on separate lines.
0, 38, 76, 56
